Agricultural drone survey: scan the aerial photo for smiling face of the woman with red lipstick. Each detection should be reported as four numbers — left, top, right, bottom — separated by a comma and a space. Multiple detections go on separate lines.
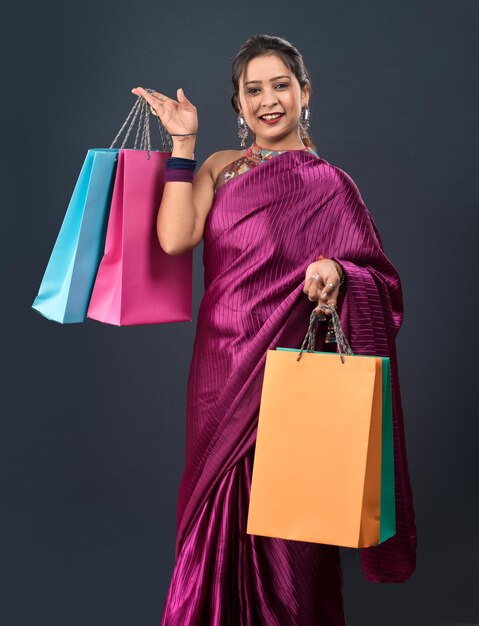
238, 53, 310, 150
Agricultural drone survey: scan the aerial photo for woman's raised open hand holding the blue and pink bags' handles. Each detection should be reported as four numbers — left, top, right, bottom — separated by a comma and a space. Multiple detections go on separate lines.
131, 87, 198, 140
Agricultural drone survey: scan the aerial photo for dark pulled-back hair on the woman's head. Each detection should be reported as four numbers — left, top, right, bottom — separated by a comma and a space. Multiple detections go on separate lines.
231, 35, 316, 150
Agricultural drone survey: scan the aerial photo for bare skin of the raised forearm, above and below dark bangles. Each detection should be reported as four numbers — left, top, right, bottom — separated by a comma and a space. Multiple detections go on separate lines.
156, 137, 196, 254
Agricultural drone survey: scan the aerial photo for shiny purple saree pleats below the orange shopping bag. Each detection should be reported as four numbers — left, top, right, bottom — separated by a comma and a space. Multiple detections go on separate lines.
162, 447, 345, 626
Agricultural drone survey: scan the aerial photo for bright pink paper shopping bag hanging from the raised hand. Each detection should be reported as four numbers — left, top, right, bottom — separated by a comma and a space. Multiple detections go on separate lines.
87, 149, 193, 326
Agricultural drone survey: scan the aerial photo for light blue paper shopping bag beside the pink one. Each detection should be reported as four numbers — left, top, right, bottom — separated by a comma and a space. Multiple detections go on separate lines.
32, 148, 119, 324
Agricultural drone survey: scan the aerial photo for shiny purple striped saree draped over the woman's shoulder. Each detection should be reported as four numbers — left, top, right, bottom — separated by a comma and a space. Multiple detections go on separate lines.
161, 150, 416, 626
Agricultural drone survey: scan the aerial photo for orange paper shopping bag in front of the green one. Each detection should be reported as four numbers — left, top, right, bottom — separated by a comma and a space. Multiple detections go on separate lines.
247, 305, 395, 548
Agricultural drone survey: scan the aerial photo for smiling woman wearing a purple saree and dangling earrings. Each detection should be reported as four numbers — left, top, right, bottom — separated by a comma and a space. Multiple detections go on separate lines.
132, 35, 416, 626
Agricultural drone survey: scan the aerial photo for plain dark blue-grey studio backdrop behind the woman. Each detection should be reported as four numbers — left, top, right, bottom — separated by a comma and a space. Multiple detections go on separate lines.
1, 0, 479, 626
